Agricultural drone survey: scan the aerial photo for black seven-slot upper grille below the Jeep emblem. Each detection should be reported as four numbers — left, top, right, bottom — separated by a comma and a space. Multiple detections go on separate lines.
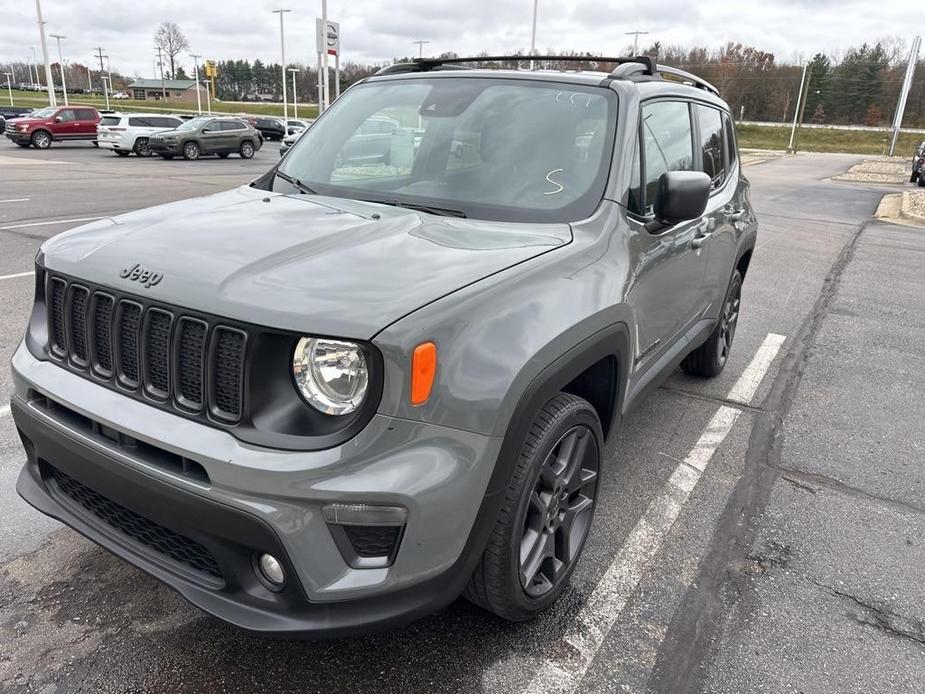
46, 276, 248, 425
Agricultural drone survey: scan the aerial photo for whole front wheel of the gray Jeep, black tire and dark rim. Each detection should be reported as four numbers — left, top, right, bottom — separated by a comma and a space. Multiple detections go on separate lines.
463, 393, 604, 622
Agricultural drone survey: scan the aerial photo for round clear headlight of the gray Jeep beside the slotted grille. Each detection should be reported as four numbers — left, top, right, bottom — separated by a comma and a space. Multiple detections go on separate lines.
292, 337, 369, 415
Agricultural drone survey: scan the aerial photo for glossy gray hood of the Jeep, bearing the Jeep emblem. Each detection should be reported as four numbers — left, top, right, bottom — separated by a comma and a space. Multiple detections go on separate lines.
42, 187, 572, 339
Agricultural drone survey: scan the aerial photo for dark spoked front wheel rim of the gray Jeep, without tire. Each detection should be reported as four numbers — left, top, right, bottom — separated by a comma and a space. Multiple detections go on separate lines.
519, 424, 600, 598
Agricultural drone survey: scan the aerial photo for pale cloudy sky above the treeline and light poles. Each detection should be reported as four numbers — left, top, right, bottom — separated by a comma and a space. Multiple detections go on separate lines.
0, 0, 925, 76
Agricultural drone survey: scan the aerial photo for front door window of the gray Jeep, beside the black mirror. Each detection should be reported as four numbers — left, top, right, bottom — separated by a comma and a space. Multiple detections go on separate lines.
642, 101, 694, 214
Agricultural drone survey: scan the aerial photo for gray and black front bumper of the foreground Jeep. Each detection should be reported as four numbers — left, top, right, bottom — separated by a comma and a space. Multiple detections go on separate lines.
11, 347, 500, 637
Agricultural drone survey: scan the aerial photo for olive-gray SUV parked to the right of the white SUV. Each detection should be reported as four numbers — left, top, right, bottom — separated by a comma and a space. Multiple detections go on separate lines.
148, 116, 262, 159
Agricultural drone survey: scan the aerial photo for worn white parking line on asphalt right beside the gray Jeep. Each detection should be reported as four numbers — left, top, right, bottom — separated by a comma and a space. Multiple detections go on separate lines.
525, 333, 784, 694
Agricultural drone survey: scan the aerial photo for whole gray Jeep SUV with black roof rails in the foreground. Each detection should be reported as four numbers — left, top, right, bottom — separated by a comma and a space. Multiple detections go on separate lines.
11, 58, 756, 636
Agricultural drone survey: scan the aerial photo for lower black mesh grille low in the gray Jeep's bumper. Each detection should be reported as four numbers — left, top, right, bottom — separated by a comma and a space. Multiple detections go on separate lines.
52, 468, 223, 580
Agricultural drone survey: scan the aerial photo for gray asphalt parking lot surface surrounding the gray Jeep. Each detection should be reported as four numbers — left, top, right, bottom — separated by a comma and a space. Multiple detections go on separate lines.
0, 143, 925, 694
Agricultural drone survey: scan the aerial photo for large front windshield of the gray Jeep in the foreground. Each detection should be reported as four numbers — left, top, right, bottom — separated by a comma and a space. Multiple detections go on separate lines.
274, 77, 616, 222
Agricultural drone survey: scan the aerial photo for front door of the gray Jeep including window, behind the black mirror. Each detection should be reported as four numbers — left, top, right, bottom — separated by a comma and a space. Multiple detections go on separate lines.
629, 99, 709, 369
